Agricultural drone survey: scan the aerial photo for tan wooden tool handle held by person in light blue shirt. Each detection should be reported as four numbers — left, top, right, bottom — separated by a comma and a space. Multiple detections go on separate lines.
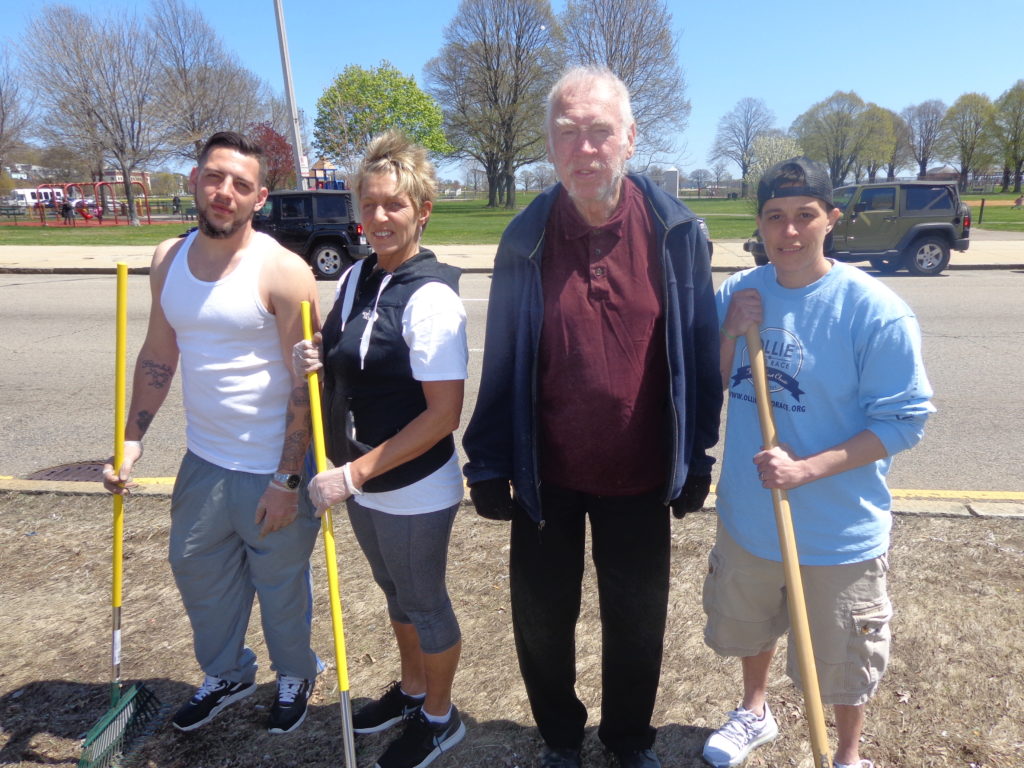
746, 326, 833, 768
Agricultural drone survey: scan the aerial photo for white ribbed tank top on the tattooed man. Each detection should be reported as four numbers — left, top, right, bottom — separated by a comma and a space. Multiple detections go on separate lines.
160, 232, 292, 474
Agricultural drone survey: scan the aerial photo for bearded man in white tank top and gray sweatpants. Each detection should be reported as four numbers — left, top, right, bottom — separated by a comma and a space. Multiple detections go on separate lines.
103, 132, 319, 733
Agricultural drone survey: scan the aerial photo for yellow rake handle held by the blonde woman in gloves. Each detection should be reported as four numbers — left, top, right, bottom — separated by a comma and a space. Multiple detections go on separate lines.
302, 301, 355, 768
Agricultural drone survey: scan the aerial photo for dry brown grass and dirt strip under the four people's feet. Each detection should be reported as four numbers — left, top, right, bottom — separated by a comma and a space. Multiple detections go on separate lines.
0, 493, 1024, 768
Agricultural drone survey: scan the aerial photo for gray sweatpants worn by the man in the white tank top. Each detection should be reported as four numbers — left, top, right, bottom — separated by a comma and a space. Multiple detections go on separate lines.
169, 452, 319, 682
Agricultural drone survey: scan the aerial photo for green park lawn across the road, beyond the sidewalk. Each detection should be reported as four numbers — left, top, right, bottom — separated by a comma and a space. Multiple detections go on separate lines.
0, 193, 1024, 246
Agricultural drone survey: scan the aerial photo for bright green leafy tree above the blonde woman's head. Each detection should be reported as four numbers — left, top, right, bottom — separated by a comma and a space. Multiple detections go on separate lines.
313, 61, 452, 174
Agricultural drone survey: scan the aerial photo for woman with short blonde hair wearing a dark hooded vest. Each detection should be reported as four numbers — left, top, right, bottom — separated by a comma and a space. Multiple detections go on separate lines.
295, 132, 468, 768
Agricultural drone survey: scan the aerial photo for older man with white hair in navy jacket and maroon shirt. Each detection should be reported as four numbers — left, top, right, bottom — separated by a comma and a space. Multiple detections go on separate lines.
464, 69, 722, 768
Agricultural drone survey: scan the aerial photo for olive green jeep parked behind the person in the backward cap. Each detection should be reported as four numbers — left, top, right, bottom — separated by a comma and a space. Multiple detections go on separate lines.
743, 181, 971, 275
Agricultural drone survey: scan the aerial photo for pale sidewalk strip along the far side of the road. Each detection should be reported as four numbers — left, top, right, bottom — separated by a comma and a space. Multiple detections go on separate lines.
0, 229, 1024, 274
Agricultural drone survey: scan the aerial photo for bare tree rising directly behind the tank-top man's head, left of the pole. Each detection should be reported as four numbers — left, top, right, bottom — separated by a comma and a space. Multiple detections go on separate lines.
150, 0, 271, 163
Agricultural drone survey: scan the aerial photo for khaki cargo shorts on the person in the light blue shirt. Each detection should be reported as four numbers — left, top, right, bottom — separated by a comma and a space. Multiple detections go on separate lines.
703, 523, 893, 706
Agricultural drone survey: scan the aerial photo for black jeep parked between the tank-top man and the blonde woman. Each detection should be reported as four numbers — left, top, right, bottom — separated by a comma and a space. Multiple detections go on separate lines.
253, 189, 370, 279
